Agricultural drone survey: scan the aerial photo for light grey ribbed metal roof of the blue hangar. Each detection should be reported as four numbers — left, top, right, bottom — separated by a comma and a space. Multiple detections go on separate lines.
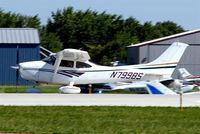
0, 28, 40, 44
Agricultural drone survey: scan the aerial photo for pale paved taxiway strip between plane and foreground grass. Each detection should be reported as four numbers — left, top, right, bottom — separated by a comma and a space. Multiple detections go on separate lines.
0, 93, 200, 107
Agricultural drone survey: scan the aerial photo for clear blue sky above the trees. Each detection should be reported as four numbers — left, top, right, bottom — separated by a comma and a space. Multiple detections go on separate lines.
0, 0, 200, 30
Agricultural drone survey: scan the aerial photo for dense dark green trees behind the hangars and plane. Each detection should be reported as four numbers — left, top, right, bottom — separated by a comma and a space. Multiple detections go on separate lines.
0, 7, 185, 65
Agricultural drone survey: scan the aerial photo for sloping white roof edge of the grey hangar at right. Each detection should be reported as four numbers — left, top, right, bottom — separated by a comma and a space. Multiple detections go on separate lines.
127, 29, 200, 47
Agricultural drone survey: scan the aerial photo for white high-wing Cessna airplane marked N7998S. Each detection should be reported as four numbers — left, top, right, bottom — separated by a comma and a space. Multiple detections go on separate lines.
18, 42, 188, 93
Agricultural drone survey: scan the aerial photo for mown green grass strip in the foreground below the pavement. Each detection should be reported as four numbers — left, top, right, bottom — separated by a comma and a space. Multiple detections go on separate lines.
0, 106, 200, 134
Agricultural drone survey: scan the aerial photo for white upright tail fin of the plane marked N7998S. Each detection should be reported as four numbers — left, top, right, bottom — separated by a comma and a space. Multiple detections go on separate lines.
149, 42, 188, 64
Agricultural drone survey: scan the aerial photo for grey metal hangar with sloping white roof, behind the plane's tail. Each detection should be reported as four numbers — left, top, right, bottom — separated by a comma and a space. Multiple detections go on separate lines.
127, 29, 200, 78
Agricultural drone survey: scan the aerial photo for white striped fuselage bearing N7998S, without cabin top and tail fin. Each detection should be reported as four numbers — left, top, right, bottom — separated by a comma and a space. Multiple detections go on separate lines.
19, 61, 160, 85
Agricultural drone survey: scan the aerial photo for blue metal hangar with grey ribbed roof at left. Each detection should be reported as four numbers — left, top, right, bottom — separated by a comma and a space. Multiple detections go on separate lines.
0, 28, 40, 85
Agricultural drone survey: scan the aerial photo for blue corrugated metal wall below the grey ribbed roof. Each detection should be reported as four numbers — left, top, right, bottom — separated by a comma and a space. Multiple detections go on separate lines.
0, 44, 40, 85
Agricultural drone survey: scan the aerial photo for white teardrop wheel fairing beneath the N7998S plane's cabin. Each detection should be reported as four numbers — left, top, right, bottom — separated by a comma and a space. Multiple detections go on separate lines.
59, 86, 81, 94
